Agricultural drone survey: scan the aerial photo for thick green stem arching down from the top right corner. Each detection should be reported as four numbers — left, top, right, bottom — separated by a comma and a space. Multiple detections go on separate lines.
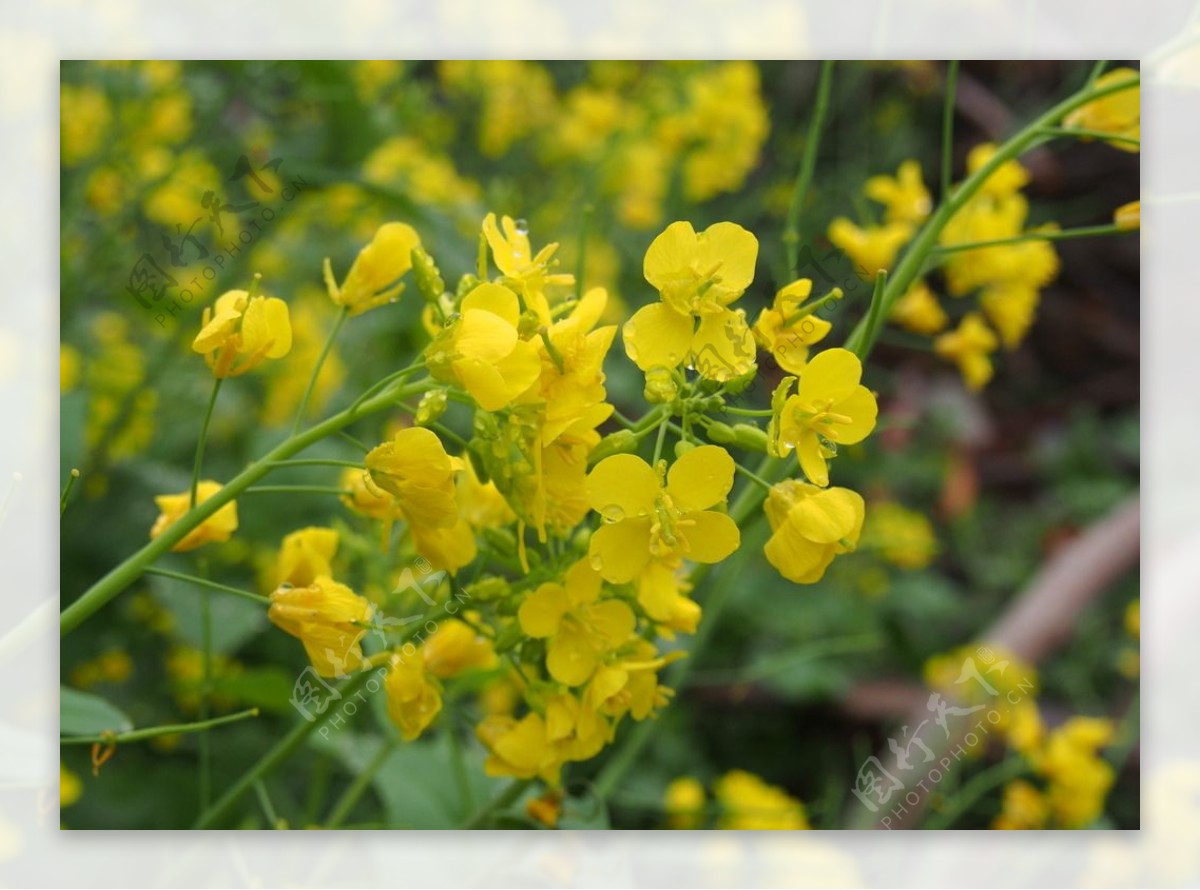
851, 70, 1141, 355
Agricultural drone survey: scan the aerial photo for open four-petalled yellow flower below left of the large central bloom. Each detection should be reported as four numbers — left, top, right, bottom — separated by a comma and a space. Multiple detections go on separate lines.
517, 560, 637, 686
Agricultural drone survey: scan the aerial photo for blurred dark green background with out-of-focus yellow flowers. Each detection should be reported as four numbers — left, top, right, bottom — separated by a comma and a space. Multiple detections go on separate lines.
60, 61, 1141, 829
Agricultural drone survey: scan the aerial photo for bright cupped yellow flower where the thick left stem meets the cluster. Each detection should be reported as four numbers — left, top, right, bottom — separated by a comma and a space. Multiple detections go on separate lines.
425, 283, 541, 411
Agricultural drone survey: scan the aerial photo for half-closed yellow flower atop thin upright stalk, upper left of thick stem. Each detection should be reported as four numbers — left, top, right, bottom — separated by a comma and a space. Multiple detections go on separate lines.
192, 290, 292, 378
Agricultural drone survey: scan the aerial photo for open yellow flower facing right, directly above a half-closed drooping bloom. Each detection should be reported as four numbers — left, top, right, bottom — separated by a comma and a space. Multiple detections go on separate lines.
773, 349, 880, 486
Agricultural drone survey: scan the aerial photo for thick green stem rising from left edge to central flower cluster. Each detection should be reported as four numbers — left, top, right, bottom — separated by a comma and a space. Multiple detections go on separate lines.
59, 380, 426, 635
